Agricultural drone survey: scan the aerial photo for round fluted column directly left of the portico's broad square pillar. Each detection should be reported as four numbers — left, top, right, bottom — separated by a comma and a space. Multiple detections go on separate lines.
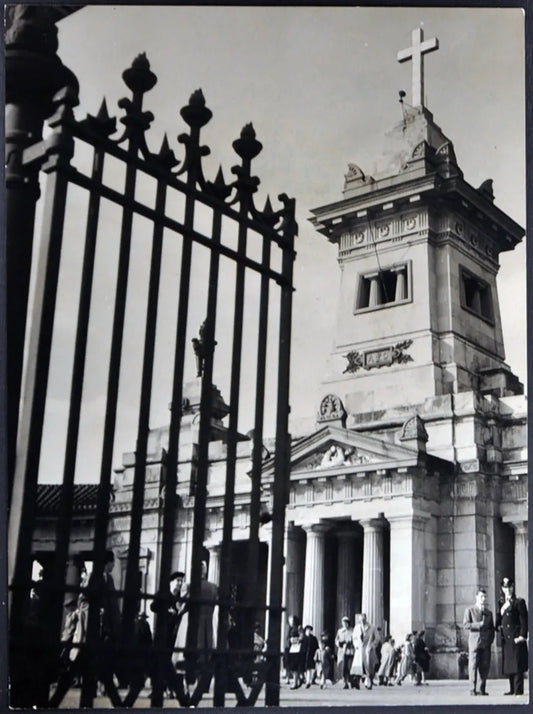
360, 519, 384, 627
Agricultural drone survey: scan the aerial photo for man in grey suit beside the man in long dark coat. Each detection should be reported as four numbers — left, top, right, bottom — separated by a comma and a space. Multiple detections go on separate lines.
463, 588, 494, 696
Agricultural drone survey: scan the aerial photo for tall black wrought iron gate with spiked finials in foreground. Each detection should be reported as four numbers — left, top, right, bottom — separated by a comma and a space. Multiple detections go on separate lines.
8, 12, 297, 707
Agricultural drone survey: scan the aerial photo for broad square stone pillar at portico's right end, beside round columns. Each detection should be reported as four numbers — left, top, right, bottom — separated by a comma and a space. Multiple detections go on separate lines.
387, 514, 428, 639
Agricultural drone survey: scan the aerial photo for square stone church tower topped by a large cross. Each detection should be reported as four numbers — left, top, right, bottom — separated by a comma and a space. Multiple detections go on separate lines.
312, 28, 523, 418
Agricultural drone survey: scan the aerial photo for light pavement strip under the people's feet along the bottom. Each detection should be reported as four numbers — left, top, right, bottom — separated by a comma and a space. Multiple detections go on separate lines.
61, 679, 529, 709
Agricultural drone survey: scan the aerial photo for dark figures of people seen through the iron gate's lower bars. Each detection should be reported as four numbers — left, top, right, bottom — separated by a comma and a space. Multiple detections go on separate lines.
49, 551, 218, 706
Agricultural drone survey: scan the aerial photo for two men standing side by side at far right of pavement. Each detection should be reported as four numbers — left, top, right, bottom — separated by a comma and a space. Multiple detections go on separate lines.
463, 578, 528, 696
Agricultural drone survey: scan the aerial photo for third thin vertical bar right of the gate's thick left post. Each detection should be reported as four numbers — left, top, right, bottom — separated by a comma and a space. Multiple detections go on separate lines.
122, 168, 170, 641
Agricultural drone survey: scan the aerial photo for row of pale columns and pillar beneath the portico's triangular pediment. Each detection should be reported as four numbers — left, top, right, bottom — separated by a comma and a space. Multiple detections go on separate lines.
284, 514, 428, 636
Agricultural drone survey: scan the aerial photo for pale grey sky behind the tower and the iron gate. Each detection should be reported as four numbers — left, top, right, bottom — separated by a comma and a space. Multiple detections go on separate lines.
34, 5, 526, 482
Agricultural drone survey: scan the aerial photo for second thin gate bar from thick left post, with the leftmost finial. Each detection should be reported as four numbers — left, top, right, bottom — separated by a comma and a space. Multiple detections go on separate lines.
80, 62, 155, 707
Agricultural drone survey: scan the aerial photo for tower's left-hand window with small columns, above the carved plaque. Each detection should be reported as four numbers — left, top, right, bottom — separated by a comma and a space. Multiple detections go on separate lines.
354, 263, 411, 312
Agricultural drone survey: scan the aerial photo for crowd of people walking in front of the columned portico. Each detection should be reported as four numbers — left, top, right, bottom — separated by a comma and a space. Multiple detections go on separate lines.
283, 613, 430, 689
